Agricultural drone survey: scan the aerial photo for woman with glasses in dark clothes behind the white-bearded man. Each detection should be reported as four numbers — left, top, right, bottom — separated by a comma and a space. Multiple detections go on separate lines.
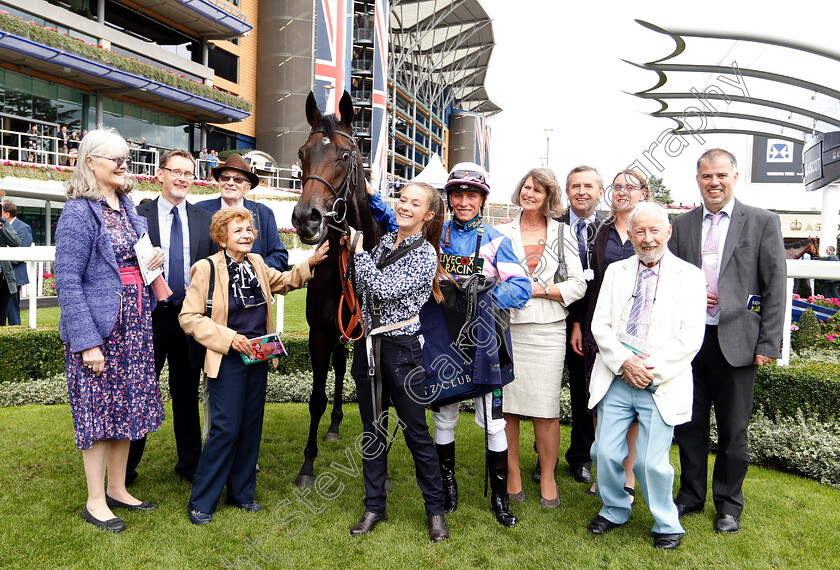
571, 166, 651, 500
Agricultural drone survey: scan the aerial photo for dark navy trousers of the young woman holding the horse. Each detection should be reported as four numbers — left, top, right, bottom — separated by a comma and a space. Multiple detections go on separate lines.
352, 336, 443, 517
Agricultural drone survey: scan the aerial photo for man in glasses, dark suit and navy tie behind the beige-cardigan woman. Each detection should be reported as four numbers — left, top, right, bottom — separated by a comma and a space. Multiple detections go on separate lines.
126, 150, 218, 484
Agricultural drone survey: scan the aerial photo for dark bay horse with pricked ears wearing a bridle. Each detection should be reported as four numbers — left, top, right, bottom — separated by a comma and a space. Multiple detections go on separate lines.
292, 91, 385, 487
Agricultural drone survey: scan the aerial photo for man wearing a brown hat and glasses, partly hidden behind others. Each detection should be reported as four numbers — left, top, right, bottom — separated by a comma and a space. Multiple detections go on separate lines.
196, 154, 289, 271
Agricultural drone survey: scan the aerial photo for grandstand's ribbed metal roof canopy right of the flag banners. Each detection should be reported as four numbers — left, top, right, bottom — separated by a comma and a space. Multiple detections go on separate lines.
389, 0, 502, 115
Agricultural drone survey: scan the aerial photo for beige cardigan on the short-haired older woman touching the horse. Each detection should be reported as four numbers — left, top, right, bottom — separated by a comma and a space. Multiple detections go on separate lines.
178, 251, 312, 378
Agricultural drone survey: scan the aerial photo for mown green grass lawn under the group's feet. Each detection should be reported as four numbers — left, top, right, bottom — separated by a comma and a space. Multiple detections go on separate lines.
0, 404, 840, 569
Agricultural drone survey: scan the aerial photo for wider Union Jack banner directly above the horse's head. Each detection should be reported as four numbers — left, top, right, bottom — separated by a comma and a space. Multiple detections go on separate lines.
315, 0, 353, 115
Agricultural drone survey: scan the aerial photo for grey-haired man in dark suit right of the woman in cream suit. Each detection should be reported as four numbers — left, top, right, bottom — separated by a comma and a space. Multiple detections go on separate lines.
534, 165, 604, 483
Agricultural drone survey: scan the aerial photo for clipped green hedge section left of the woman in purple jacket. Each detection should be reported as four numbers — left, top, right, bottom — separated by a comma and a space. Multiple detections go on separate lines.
0, 327, 64, 382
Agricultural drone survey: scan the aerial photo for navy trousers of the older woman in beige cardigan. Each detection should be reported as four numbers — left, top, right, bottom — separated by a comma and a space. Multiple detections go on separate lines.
189, 350, 268, 513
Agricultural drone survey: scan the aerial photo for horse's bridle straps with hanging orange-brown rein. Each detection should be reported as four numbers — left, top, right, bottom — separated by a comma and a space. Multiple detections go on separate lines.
301, 124, 365, 344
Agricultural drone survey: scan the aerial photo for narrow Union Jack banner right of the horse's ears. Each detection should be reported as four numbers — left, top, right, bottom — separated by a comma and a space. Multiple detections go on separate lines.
370, 0, 391, 190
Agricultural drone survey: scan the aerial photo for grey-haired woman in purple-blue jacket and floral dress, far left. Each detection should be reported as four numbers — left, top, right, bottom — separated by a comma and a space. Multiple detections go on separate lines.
55, 129, 164, 532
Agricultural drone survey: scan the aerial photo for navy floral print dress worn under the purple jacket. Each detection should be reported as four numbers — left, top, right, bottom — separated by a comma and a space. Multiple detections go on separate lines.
64, 199, 164, 449
